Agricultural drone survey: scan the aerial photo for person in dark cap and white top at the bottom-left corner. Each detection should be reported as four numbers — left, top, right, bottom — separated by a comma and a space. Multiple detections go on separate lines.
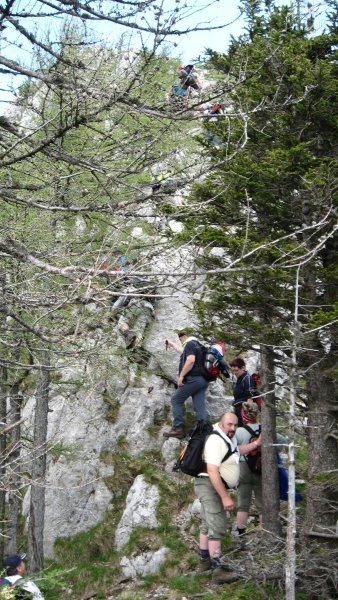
0, 554, 43, 600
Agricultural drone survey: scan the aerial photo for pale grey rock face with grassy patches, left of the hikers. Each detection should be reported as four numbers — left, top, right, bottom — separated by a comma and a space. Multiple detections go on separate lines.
24, 245, 231, 564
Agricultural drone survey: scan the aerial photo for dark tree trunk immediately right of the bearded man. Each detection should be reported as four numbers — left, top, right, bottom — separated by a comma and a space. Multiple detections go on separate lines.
261, 346, 281, 537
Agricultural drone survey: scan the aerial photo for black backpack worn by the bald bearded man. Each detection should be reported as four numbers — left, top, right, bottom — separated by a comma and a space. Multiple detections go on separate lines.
173, 421, 236, 485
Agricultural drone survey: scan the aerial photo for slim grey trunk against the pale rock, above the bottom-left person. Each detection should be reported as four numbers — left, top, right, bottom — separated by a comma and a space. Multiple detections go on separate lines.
28, 352, 50, 572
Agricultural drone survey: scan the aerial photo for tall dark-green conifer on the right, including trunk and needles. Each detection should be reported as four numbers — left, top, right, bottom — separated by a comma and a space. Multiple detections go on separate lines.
187, 2, 338, 586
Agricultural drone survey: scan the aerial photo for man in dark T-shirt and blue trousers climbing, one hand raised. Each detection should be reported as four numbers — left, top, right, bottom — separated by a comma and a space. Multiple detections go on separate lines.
163, 331, 209, 440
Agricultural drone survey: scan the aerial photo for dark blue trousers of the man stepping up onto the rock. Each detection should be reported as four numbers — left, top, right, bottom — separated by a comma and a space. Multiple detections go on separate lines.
171, 375, 208, 427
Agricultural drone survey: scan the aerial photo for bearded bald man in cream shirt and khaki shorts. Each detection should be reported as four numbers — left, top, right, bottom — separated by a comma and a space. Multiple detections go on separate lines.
194, 412, 261, 583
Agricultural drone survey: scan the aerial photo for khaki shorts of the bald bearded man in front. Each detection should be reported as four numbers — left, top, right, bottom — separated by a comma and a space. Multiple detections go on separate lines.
194, 477, 227, 540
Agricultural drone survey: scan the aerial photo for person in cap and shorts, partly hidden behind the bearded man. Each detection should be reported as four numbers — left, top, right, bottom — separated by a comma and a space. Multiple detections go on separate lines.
236, 402, 287, 539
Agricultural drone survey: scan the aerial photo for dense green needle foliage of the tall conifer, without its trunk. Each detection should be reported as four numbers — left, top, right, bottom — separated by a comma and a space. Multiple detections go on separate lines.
182, 1, 337, 349
